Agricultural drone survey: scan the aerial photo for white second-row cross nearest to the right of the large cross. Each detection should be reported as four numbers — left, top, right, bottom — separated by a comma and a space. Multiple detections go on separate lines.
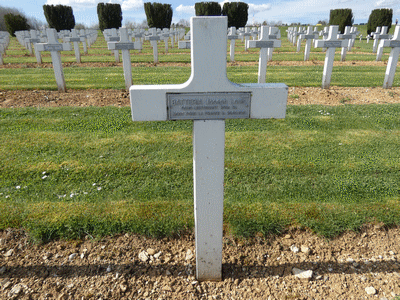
247, 26, 281, 83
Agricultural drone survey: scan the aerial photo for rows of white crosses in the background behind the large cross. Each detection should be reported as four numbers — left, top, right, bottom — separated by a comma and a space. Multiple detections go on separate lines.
3, 26, 400, 91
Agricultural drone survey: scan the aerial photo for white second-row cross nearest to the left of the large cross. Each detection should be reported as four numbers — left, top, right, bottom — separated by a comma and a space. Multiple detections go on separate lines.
108, 27, 142, 90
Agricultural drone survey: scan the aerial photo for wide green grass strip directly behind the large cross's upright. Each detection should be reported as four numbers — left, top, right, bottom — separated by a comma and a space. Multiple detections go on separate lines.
0, 105, 400, 241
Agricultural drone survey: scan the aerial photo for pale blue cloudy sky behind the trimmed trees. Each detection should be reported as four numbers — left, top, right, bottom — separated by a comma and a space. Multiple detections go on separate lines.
0, 0, 400, 26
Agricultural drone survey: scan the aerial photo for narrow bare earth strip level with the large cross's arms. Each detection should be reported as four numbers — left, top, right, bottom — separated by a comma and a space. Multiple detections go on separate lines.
0, 86, 400, 107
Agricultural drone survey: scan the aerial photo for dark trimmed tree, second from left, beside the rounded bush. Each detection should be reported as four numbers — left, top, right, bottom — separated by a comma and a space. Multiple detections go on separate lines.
43, 5, 75, 31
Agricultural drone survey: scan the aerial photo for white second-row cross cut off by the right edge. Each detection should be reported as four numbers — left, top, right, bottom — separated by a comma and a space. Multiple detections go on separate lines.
381, 25, 400, 89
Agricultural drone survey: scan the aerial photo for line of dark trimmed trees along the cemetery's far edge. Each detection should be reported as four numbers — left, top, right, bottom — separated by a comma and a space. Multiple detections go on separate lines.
0, 2, 393, 35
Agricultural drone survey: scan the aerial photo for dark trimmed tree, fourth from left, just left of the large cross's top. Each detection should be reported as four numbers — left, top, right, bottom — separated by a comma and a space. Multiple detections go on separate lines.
144, 2, 172, 29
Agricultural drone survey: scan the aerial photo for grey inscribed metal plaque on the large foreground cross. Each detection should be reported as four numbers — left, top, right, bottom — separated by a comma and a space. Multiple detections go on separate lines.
167, 92, 251, 120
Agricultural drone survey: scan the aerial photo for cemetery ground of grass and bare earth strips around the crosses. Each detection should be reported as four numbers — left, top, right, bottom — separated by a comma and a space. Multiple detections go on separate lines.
0, 25, 400, 299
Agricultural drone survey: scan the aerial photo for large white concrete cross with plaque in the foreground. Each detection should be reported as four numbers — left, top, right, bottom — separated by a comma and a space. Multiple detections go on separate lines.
130, 17, 288, 280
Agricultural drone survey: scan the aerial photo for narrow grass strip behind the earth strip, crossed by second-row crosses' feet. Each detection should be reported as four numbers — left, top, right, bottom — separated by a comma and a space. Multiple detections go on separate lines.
0, 65, 394, 90
